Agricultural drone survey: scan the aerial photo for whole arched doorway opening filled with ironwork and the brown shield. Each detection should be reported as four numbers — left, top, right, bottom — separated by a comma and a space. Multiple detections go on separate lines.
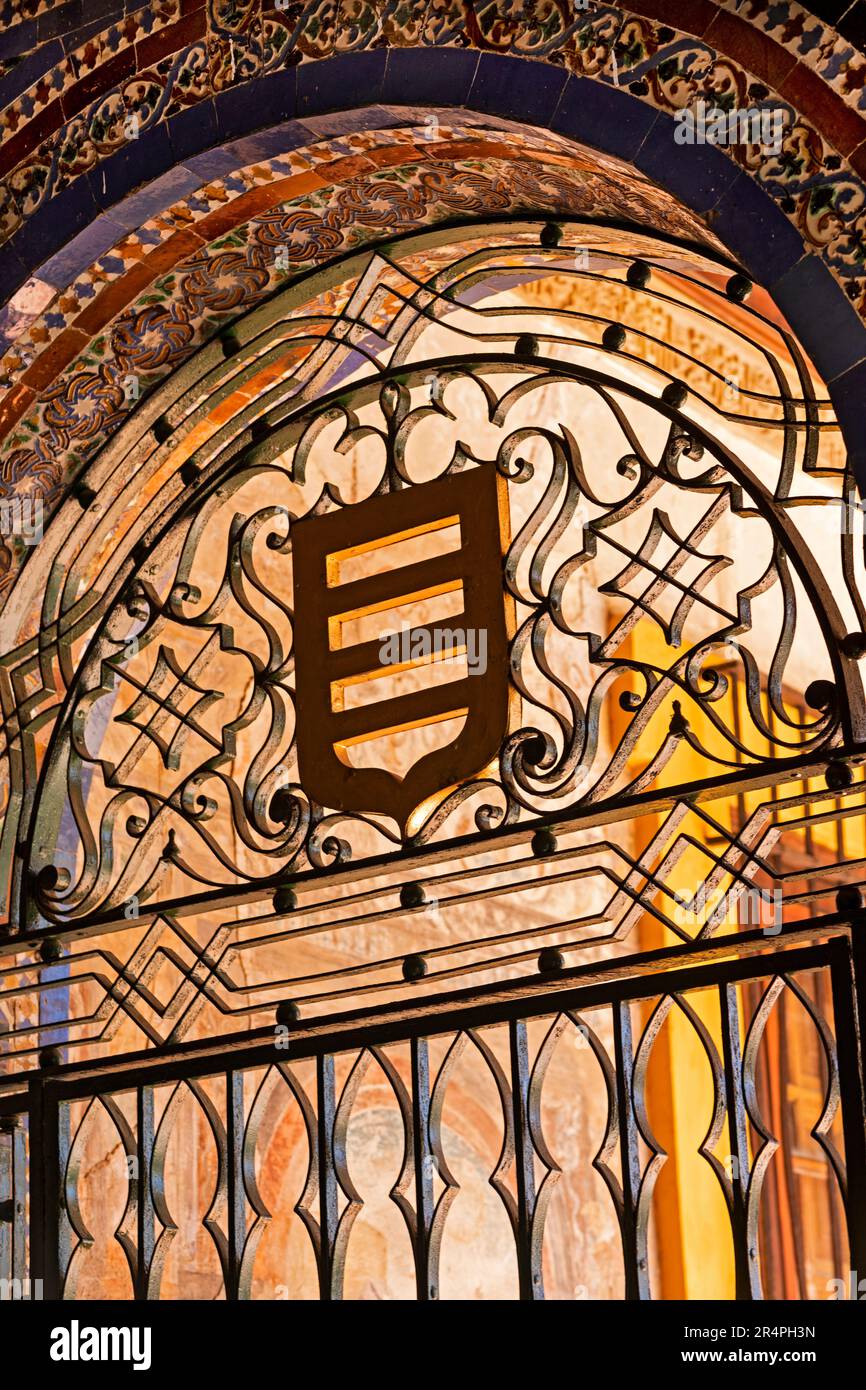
3, 2, 863, 1298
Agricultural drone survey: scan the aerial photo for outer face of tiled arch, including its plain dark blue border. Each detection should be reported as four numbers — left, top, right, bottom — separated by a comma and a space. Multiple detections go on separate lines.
0, 10, 866, 480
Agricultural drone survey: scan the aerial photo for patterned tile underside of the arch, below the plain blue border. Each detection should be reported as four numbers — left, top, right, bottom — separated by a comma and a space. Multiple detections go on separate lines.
0, 125, 717, 569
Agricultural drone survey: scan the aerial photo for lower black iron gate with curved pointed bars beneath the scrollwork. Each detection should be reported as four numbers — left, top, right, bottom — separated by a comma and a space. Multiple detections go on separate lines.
0, 915, 866, 1300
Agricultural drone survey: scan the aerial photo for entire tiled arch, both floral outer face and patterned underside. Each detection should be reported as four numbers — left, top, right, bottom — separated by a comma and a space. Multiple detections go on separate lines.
0, 0, 866, 611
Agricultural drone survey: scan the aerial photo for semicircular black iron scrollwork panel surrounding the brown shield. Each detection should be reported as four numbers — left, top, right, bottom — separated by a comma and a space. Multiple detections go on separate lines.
27, 356, 859, 922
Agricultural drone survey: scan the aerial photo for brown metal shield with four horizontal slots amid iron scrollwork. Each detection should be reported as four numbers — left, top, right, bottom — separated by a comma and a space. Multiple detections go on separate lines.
292, 464, 513, 831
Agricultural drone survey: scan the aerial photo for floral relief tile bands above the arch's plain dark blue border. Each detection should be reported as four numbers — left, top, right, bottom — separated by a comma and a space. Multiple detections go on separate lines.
0, 0, 866, 268
